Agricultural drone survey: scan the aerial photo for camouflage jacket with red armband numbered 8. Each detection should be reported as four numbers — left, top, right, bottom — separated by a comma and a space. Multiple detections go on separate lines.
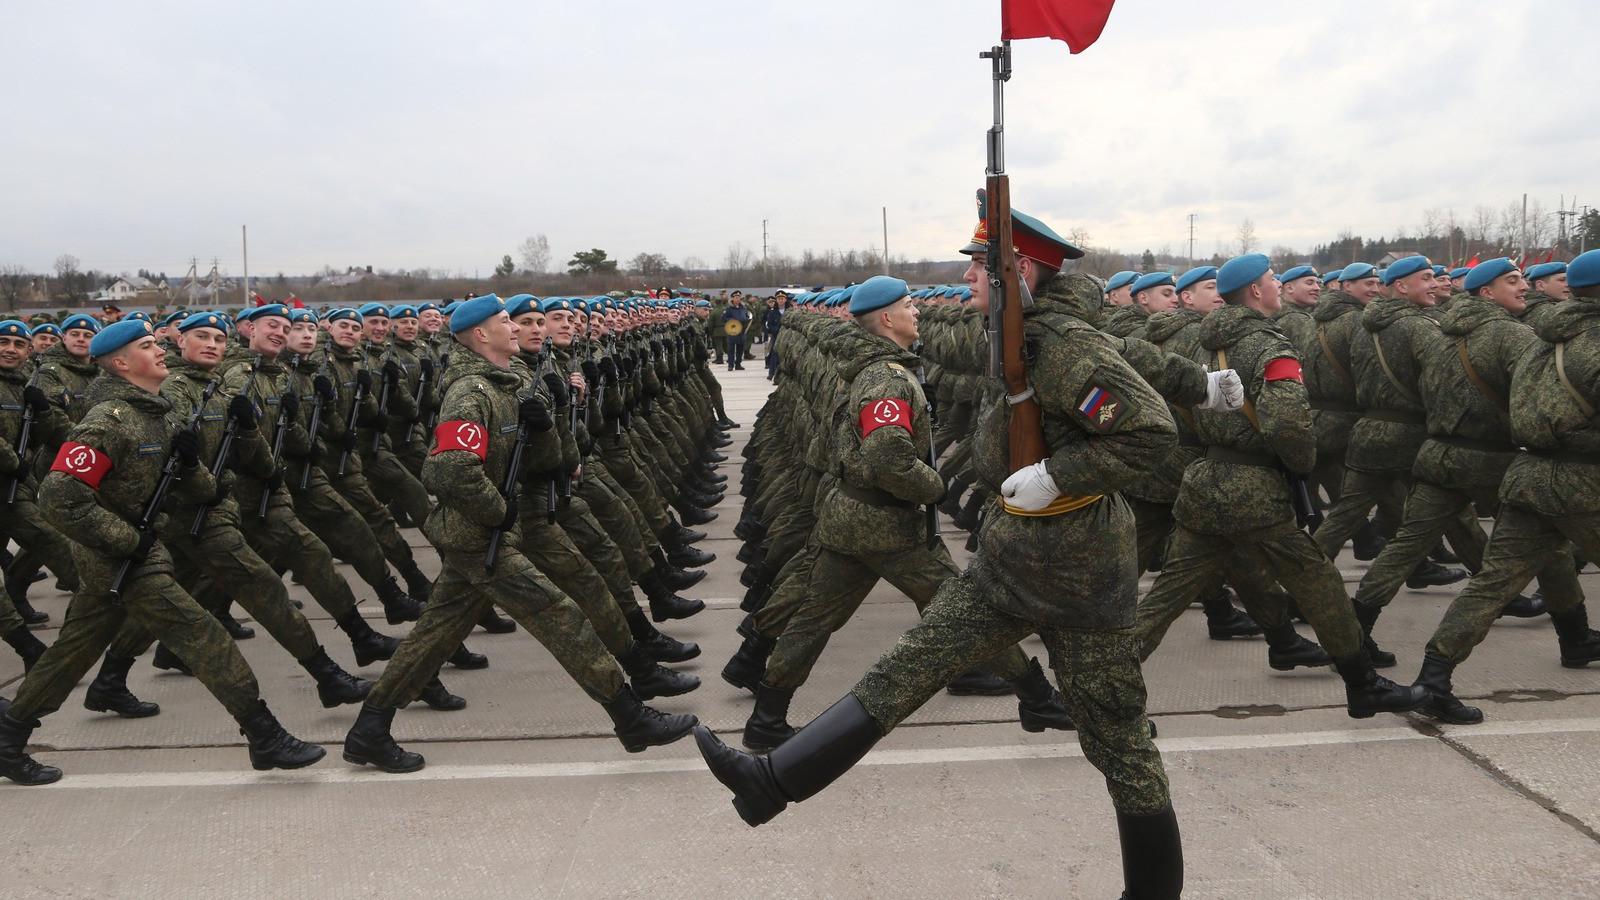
38, 375, 216, 594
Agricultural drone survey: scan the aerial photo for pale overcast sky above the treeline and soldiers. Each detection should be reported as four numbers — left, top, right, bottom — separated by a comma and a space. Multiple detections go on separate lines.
0, 0, 1600, 275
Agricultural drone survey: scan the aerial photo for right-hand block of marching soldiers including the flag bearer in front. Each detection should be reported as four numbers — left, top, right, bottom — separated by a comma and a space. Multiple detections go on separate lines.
696, 201, 1600, 898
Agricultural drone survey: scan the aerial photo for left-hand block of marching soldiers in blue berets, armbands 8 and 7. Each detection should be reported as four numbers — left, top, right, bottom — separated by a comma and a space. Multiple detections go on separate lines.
0, 295, 736, 785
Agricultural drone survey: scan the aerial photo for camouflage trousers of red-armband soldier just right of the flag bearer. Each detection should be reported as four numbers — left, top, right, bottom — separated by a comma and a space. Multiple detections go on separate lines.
1133, 522, 1362, 660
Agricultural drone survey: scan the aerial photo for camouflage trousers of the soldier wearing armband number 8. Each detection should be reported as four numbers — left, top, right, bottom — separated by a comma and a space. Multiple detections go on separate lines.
10, 569, 261, 721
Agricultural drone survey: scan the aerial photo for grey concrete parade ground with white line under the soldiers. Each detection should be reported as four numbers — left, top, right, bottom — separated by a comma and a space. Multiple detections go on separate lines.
0, 352, 1600, 900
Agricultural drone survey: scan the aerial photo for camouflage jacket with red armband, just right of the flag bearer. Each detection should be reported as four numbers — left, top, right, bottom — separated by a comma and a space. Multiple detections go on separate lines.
1173, 306, 1317, 535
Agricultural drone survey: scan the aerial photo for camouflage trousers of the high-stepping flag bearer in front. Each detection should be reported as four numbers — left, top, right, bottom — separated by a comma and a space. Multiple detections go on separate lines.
851, 570, 1171, 814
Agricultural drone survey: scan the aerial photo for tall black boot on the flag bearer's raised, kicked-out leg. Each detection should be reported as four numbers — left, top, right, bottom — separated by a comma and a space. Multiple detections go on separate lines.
694, 693, 883, 828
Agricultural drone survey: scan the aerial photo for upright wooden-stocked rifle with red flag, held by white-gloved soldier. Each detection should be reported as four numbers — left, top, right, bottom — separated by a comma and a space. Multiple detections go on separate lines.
978, 42, 1050, 472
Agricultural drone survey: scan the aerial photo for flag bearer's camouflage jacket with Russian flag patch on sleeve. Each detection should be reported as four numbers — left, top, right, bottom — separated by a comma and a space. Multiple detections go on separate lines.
973, 274, 1178, 629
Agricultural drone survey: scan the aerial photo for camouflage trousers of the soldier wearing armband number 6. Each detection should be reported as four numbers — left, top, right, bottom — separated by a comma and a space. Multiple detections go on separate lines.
762, 543, 1027, 690
